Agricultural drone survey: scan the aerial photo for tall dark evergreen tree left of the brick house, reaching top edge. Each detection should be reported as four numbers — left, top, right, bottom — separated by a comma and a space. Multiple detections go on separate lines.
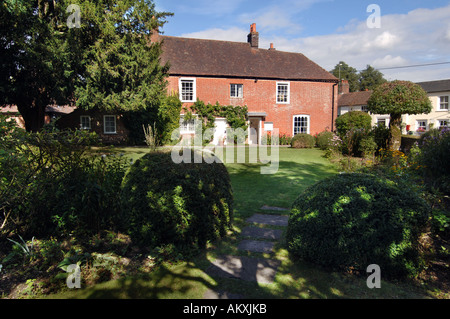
0, 0, 171, 131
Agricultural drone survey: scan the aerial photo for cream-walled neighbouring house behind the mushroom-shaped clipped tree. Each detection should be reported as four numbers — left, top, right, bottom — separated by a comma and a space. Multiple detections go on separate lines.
338, 79, 450, 135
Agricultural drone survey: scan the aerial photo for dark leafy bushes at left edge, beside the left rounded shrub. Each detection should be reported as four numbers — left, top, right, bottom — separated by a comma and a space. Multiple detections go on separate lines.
0, 126, 126, 237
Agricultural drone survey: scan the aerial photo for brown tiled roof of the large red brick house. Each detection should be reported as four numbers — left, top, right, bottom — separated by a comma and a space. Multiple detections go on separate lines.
161, 36, 338, 82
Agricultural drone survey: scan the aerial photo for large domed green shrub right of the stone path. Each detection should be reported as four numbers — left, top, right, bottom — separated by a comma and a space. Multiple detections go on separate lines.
287, 173, 429, 278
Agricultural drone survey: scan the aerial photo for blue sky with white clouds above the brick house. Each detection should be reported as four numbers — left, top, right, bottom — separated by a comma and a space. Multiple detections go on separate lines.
155, 0, 450, 82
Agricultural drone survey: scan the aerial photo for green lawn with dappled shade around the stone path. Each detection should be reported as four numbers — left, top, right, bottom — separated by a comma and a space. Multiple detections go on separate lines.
49, 147, 427, 299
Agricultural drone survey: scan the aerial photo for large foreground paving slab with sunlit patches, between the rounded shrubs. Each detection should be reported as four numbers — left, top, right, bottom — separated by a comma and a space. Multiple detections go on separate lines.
206, 255, 281, 284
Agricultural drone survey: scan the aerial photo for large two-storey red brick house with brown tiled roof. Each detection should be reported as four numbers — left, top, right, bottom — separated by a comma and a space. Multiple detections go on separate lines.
158, 24, 339, 144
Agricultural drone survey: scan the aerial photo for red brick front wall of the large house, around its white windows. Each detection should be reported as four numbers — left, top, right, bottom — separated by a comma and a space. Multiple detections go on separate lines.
168, 76, 338, 136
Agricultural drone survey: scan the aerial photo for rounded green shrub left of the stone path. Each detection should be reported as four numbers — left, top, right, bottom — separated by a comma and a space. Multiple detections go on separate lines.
122, 150, 233, 249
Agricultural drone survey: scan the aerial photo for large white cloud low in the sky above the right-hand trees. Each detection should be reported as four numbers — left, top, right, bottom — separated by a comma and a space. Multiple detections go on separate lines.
268, 5, 450, 81
